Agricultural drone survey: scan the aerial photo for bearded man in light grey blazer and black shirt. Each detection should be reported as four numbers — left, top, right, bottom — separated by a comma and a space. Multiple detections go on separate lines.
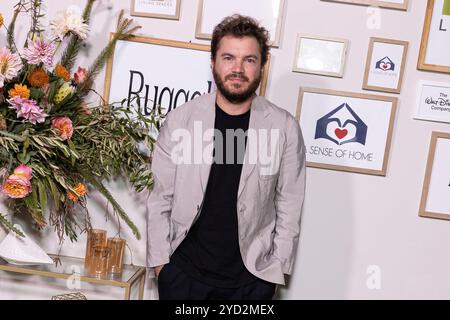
147, 15, 305, 299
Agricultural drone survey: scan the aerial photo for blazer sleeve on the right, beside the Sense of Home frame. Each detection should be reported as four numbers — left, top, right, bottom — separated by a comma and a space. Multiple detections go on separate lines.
273, 115, 306, 274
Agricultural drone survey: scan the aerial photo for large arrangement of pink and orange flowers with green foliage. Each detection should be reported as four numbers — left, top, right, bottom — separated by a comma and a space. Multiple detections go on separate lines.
0, 0, 159, 241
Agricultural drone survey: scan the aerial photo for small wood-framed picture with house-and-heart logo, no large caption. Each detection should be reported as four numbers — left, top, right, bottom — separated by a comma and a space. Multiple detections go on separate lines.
363, 38, 408, 93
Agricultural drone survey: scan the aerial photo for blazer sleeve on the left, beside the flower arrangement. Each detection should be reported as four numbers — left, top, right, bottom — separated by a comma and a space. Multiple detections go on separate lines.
147, 113, 176, 267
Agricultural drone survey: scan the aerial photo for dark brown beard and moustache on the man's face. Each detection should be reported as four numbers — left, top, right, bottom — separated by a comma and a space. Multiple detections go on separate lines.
213, 68, 262, 103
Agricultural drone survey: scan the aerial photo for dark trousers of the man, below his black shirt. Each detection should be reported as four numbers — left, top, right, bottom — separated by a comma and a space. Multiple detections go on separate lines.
158, 263, 276, 300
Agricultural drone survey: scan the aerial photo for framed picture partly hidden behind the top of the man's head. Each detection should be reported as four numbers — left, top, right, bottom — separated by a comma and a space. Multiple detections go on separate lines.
195, 0, 284, 47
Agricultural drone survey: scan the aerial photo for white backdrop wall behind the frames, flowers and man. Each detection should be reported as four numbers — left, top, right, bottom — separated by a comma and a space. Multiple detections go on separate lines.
0, 0, 450, 299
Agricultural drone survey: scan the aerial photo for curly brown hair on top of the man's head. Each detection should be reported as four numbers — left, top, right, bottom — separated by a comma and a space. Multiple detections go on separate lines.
211, 14, 270, 67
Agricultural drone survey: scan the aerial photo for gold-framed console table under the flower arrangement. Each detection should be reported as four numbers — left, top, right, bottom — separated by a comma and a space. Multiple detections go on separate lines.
0, 254, 146, 300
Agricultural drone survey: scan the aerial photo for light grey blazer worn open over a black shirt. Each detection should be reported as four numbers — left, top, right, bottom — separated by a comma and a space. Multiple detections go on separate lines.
147, 93, 305, 284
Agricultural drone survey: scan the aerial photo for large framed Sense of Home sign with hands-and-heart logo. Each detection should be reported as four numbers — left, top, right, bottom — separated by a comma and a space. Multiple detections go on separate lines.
296, 88, 397, 176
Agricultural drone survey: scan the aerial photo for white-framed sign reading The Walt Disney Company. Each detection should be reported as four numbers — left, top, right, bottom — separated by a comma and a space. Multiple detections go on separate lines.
414, 81, 450, 123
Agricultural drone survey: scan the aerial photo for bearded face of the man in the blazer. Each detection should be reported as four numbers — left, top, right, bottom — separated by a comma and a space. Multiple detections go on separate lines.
211, 36, 261, 103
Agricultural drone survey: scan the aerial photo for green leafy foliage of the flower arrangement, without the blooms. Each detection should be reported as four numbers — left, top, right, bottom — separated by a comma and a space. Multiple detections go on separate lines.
0, 0, 161, 241
